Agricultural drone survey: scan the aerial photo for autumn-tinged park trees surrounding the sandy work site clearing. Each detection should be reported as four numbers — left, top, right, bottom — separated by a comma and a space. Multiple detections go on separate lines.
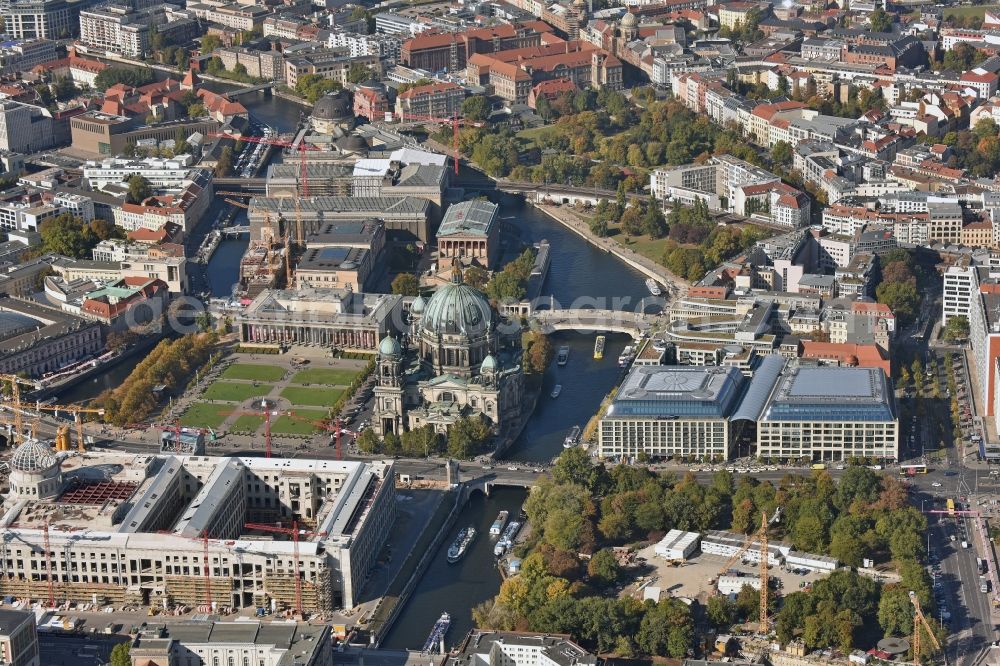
473, 449, 943, 658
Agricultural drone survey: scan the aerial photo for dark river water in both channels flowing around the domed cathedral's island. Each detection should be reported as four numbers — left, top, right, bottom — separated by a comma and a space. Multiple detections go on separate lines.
62, 84, 648, 649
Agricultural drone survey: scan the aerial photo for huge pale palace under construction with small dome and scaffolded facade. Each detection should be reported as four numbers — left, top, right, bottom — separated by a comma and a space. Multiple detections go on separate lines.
0, 439, 395, 612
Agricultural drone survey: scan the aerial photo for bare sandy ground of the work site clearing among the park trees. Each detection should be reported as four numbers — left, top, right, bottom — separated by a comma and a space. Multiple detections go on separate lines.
624, 544, 825, 602
